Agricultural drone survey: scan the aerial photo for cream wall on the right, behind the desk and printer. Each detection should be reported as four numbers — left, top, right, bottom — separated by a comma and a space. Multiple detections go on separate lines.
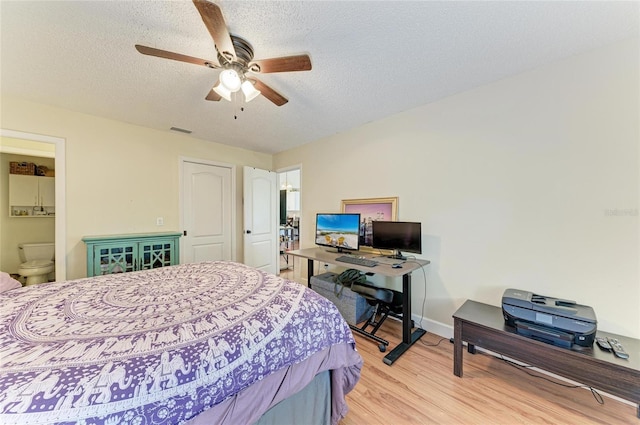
274, 39, 640, 338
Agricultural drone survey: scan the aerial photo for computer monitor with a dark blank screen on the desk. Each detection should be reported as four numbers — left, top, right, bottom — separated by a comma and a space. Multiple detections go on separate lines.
371, 221, 422, 260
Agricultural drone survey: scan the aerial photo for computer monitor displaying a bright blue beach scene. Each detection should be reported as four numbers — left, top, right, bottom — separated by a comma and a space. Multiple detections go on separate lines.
316, 213, 360, 252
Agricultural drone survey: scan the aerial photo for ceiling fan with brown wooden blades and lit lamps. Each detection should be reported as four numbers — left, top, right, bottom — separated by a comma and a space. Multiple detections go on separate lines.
136, 0, 311, 106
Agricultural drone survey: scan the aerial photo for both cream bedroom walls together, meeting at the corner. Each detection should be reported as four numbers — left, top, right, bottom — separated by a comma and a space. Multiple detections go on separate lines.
0, 39, 640, 337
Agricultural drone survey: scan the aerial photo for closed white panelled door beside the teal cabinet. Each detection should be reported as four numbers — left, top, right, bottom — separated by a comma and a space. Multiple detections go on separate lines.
181, 160, 234, 263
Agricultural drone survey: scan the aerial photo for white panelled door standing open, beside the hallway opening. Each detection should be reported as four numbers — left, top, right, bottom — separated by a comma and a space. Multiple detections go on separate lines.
243, 167, 280, 274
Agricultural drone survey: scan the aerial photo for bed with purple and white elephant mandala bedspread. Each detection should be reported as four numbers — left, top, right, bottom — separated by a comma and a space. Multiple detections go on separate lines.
0, 261, 362, 425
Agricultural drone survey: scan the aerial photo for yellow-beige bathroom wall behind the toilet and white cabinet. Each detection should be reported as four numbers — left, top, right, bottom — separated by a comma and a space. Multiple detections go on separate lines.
0, 153, 55, 273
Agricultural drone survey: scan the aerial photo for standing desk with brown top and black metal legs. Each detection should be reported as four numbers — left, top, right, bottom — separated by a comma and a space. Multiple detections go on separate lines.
287, 248, 430, 365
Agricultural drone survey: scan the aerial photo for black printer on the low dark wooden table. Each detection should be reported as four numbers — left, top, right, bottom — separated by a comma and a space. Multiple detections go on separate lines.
502, 289, 598, 348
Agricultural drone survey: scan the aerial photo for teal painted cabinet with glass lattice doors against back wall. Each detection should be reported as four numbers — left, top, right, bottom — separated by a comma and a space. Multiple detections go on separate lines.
82, 232, 182, 276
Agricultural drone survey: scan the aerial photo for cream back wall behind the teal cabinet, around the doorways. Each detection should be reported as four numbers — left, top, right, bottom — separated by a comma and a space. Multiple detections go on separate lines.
0, 96, 272, 279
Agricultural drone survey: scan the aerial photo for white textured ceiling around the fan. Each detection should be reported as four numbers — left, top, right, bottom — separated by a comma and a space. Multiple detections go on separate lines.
0, 0, 640, 153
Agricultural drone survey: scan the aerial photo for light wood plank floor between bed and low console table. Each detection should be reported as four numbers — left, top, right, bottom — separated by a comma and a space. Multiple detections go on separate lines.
281, 272, 640, 425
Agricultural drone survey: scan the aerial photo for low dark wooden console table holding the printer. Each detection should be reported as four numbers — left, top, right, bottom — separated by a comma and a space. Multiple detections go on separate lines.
453, 300, 640, 418
